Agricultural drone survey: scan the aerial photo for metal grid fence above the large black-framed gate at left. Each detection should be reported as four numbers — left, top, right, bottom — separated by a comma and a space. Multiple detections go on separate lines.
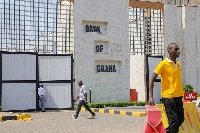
0, 0, 74, 54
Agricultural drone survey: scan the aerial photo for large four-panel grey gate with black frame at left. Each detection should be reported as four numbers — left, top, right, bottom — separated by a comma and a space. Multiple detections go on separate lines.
0, 52, 73, 111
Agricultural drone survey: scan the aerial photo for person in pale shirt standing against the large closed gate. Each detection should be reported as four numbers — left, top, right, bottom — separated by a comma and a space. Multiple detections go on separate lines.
38, 85, 46, 112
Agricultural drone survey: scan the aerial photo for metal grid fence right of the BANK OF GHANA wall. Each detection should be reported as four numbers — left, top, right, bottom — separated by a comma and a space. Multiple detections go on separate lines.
129, 8, 164, 55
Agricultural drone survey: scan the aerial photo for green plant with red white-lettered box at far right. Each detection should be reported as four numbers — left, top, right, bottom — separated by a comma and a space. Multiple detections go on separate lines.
183, 84, 197, 101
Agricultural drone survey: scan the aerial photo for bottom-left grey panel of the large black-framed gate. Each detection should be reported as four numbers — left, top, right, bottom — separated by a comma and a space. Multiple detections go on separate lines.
2, 83, 36, 111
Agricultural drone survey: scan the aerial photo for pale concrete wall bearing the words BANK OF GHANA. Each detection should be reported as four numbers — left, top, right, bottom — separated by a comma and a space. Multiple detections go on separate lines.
74, 0, 130, 102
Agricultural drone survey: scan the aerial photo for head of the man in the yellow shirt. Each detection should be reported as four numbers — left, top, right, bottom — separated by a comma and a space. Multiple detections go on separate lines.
167, 43, 180, 59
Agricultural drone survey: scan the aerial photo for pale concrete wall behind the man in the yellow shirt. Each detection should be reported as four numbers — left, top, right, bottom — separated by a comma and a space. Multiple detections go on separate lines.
164, 4, 200, 93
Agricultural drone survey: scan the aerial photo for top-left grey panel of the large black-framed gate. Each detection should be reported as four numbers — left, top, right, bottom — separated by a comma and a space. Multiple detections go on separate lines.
2, 54, 36, 80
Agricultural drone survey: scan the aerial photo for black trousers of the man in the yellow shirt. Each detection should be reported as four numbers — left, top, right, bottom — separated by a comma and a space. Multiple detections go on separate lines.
163, 97, 184, 133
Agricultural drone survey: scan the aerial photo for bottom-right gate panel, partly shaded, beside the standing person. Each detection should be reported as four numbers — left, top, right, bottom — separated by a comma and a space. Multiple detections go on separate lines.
40, 83, 72, 108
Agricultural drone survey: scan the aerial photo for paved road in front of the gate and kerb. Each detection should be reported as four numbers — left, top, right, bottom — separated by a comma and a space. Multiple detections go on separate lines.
0, 110, 145, 133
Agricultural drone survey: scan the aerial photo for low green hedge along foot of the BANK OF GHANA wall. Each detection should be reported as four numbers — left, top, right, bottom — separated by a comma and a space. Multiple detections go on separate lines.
88, 101, 146, 108
